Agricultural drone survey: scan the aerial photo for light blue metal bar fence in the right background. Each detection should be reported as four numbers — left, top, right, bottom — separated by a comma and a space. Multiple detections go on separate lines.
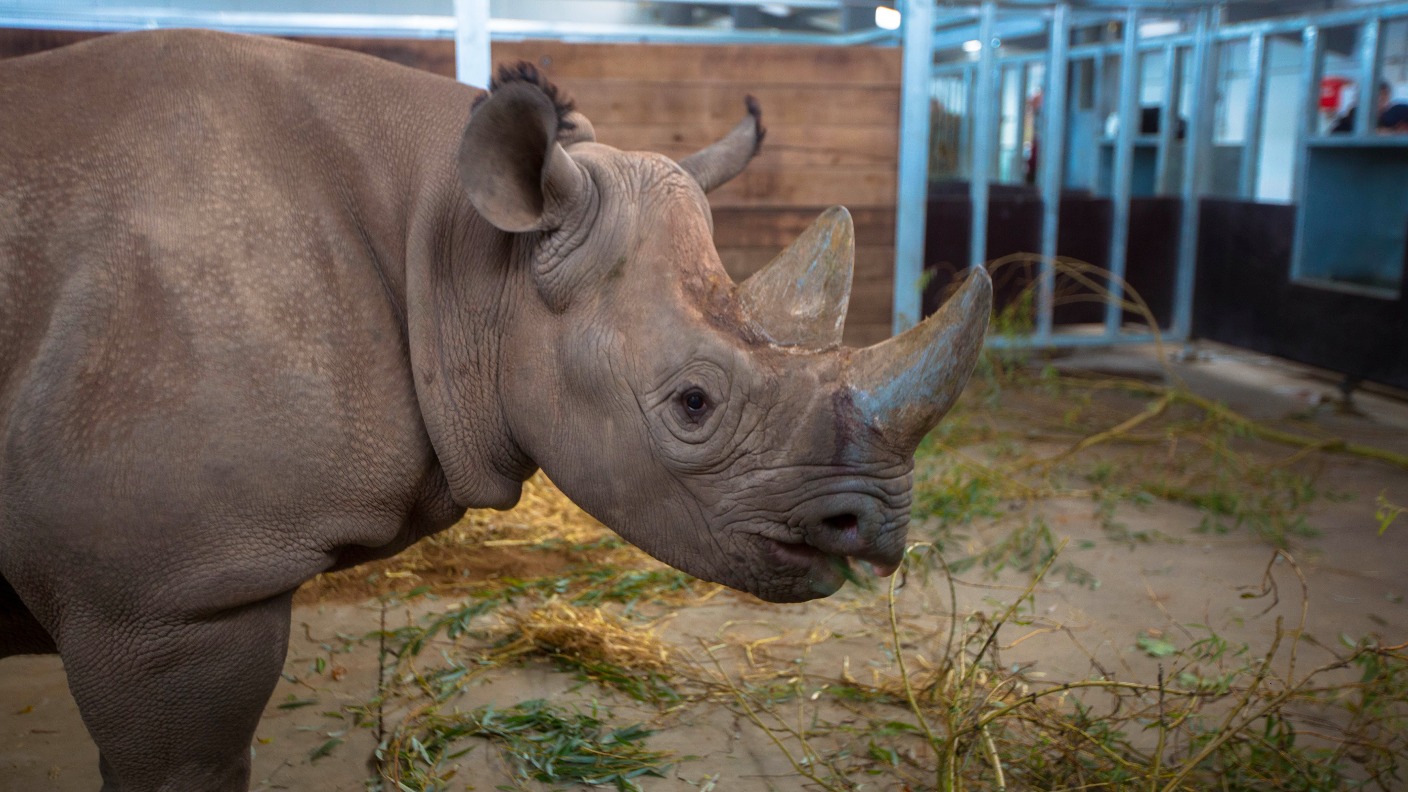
934, 1, 1408, 347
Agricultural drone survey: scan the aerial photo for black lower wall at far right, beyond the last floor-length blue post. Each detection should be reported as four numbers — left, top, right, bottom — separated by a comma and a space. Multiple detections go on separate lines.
1193, 199, 1408, 388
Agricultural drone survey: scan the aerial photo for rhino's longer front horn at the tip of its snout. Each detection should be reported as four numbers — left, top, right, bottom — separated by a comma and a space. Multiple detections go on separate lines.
846, 266, 993, 450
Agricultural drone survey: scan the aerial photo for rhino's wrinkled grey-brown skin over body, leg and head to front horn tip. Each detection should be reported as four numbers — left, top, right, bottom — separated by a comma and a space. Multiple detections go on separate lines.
0, 32, 988, 791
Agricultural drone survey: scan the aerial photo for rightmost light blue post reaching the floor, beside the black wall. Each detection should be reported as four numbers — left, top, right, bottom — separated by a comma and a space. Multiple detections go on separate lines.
1171, 8, 1217, 341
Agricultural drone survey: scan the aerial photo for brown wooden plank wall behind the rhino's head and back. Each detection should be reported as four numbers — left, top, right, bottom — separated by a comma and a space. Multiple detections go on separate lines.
0, 31, 900, 344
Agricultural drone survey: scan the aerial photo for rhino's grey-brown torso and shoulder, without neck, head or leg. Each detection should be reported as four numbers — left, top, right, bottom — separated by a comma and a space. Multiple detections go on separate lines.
0, 31, 472, 606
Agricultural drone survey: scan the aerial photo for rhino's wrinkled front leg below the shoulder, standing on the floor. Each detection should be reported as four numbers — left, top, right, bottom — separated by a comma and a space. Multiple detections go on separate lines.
59, 592, 293, 792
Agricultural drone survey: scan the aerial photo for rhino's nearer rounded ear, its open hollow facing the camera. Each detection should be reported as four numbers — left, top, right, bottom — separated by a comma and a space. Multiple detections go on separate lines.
459, 82, 587, 233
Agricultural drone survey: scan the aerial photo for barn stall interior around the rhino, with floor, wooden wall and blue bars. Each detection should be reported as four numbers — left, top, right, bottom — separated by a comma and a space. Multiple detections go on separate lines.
0, 0, 1408, 791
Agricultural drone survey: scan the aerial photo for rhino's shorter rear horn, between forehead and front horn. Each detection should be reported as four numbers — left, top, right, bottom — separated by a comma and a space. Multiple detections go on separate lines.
738, 206, 856, 349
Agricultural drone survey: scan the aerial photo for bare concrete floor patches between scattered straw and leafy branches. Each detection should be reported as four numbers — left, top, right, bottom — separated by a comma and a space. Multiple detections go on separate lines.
0, 341, 1408, 792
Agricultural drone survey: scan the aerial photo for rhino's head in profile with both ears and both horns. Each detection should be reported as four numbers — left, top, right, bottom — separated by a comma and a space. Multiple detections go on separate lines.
439, 70, 991, 602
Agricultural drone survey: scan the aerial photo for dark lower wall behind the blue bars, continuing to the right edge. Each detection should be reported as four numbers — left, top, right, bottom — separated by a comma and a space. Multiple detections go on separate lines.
924, 182, 1408, 388
